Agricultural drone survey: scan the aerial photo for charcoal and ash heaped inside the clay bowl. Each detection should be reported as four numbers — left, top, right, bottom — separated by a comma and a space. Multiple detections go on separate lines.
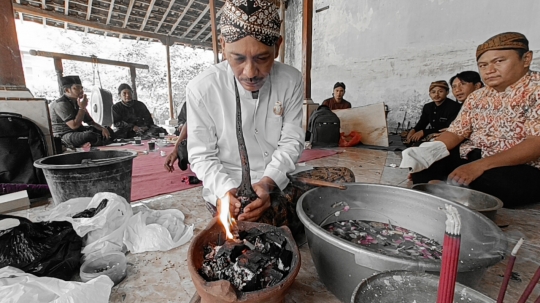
199, 228, 293, 292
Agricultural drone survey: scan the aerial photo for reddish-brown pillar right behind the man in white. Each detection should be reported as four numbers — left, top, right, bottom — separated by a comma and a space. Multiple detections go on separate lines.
302, 0, 318, 130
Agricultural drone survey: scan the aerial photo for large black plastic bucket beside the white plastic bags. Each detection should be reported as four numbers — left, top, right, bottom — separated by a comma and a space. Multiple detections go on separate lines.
34, 150, 137, 205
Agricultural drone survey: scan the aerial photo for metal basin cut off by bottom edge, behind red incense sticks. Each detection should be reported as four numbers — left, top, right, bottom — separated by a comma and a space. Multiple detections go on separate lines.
351, 271, 495, 303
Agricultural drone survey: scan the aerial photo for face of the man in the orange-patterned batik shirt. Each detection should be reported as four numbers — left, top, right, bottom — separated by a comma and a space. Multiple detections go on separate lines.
477, 49, 532, 92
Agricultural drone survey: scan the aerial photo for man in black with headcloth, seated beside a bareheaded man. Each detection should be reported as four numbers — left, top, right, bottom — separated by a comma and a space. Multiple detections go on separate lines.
407, 80, 460, 143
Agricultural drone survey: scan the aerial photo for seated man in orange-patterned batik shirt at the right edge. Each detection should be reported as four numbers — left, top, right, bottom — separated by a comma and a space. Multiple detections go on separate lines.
402, 33, 540, 207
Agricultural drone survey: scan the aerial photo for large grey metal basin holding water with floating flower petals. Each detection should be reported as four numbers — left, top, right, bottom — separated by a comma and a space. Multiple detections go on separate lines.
296, 183, 507, 302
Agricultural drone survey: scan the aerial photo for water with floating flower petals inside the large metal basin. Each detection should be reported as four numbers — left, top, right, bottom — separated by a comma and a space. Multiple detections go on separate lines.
323, 220, 442, 260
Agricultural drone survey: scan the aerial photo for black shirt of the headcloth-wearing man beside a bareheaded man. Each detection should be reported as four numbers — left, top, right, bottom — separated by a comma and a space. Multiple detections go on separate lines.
414, 98, 461, 136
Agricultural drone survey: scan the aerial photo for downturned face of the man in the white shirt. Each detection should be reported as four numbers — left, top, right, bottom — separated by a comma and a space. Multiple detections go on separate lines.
221, 36, 282, 92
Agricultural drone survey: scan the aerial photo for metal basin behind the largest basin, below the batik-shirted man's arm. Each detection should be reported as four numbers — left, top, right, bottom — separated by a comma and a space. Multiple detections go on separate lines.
412, 183, 503, 221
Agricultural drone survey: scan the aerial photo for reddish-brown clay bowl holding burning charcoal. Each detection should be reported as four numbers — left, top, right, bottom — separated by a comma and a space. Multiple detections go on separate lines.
188, 218, 300, 303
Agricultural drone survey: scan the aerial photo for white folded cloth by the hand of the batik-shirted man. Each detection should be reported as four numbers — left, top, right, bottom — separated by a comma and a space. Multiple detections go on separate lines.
399, 141, 450, 173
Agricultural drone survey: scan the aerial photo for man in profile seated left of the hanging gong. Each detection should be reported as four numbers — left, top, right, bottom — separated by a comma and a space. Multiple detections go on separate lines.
50, 76, 112, 148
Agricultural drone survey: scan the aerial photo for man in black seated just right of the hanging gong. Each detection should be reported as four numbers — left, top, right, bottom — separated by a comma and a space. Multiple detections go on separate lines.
112, 83, 167, 138
